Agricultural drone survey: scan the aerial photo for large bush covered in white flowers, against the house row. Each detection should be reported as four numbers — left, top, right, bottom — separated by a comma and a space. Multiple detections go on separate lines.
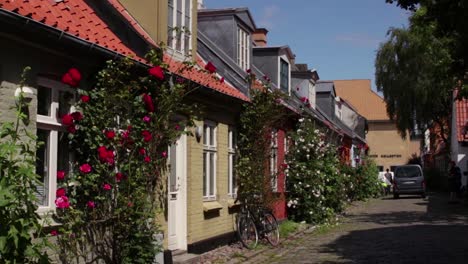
286, 118, 346, 223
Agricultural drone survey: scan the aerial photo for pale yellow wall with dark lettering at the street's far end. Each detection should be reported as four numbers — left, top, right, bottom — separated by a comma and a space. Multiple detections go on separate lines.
366, 121, 420, 170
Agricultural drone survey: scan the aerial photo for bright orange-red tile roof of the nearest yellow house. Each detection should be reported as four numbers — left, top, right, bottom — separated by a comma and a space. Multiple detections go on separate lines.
0, 0, 249, 101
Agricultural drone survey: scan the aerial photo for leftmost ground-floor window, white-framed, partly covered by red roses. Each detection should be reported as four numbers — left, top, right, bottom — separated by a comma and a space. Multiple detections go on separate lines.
36, 78, 75, 212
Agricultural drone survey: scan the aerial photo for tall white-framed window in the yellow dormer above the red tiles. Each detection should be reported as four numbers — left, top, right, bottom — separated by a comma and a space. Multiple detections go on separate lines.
167, 0, 192, 55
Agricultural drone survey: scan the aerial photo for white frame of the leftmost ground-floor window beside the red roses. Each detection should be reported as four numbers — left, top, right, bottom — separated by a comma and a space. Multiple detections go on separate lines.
36, 77, 76, 214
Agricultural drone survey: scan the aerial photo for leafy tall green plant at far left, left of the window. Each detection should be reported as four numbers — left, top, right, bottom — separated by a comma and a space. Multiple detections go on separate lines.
0, 68, 49, 263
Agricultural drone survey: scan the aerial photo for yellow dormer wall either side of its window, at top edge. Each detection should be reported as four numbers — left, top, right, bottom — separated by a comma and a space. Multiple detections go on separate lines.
119, 0, 197, 57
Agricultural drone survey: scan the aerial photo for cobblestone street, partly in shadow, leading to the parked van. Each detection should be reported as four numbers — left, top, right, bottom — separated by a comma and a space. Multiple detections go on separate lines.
230, 194, 468, 264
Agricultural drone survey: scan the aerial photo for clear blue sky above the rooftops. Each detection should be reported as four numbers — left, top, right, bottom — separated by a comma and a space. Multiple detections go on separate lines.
204, 0, 409, 88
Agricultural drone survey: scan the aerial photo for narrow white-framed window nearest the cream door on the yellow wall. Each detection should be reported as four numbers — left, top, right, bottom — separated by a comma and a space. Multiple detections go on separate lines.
203, 121, 217, 200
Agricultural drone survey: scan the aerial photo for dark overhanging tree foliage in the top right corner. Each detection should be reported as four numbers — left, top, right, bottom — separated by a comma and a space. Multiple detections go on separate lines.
386, 0, 468, 87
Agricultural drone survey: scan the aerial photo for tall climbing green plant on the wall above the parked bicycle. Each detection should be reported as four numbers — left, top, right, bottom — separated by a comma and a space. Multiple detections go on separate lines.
236, 89, 285, 206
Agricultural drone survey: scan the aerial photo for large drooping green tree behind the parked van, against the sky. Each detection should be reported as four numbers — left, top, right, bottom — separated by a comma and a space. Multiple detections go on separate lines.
375, 8, 456, 143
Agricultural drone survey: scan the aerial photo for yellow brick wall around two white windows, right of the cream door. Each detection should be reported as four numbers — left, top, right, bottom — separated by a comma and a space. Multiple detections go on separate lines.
187, 121, 238, 244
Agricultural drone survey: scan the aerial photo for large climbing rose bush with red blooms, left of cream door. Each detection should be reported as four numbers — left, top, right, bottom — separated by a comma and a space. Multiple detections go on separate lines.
56, 51, 200, 263
